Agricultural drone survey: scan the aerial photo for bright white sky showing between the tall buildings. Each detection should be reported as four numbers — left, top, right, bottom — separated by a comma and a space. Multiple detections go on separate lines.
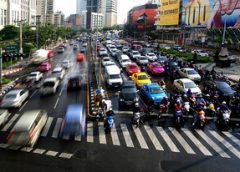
54, 0, 148, 24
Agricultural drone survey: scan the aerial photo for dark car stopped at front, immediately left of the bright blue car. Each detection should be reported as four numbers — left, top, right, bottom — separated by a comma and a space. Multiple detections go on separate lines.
119, 81, 138, 107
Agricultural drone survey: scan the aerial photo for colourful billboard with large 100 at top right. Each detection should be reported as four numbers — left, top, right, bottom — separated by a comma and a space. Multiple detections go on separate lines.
181, 0, 240, 28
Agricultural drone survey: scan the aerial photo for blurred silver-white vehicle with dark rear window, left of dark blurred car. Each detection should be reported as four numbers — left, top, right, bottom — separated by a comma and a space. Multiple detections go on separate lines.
39, 77, 60, 96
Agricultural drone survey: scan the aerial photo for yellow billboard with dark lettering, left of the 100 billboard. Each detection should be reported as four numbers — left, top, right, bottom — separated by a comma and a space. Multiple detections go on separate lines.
160, 0, 180, 26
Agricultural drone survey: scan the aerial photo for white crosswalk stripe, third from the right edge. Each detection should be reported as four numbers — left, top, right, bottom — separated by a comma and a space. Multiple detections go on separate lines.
195, 130, 230, 158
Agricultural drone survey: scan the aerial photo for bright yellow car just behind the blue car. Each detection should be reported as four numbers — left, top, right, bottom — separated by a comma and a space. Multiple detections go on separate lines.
130, 72, 151, 89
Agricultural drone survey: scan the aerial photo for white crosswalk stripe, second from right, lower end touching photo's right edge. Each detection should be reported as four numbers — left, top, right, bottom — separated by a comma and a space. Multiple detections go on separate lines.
209, 130, 240, 159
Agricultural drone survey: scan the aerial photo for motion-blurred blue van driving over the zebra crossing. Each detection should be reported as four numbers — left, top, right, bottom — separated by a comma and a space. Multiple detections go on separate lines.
60, 104, 86, 139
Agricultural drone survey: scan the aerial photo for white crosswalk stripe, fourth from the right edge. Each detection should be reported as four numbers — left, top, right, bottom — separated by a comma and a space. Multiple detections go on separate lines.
181, 128, 212, 156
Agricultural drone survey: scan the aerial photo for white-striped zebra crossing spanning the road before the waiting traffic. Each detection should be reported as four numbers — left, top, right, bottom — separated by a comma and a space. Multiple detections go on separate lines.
0, 114, 240, 159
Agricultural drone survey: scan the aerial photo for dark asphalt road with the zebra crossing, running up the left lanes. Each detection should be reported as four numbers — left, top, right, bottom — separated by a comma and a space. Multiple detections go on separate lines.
0, 42, 240, 172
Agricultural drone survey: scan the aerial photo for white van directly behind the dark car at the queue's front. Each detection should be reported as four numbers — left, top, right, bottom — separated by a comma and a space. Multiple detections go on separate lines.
105, 65, 123, 88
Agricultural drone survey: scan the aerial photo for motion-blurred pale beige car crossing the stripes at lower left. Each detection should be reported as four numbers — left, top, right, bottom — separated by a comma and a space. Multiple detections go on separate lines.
6, 110, 48, 147
